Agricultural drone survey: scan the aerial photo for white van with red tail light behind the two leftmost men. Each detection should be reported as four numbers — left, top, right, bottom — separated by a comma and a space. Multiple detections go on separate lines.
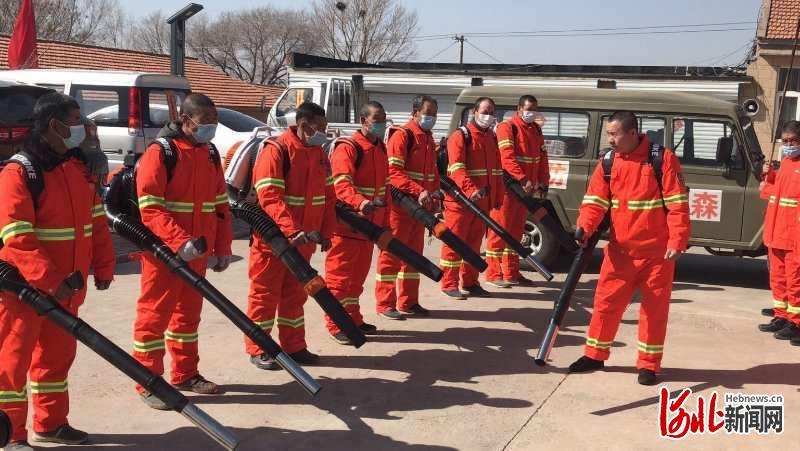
0, 69, 190, 169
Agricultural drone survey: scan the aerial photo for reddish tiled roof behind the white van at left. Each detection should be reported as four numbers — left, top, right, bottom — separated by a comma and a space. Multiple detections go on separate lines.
0, 36, 283, 108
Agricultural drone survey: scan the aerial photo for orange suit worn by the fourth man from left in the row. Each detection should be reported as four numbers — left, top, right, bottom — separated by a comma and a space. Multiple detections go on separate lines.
325, 131, 388, 335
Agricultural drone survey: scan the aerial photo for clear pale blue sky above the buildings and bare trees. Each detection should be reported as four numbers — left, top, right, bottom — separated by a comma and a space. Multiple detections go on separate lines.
130, 0, 761, 65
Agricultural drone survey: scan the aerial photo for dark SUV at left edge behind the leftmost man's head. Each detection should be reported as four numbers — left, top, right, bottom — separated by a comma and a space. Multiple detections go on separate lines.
0, 81, 50, 160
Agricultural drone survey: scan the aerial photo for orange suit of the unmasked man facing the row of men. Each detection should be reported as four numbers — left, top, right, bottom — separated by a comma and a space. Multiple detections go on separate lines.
577, 136, 690, 372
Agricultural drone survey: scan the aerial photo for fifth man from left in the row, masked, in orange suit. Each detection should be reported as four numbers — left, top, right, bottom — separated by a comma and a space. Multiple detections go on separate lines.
375, 95, 442, 320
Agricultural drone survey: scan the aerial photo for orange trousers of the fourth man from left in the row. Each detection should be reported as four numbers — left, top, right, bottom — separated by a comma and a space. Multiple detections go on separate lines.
325, 236, 373, 335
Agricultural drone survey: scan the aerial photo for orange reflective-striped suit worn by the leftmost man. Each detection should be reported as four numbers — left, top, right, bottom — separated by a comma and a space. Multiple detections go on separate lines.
0, 152, 114, 441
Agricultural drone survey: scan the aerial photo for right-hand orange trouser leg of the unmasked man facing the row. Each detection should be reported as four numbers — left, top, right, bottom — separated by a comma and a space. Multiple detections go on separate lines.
636, 258, 675, 372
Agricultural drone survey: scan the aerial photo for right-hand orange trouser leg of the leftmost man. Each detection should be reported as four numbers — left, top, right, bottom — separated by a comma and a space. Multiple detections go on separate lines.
29, 299, 80, 432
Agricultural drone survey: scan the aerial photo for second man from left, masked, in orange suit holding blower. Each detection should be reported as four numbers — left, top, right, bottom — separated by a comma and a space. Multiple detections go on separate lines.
133, 93, 233, 410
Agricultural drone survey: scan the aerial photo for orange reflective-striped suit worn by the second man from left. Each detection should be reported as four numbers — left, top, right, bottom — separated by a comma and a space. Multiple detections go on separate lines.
133, 136, 233, 392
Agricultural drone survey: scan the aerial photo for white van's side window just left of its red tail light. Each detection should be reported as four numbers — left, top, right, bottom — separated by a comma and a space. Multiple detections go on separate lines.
72, 85, 128, 127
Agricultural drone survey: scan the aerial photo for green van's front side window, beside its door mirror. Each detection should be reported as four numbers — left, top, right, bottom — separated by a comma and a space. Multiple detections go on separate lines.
672, 118, 742, 167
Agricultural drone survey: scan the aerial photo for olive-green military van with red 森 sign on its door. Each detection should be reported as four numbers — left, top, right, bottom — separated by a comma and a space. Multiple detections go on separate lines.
450, 87, 766, 263
